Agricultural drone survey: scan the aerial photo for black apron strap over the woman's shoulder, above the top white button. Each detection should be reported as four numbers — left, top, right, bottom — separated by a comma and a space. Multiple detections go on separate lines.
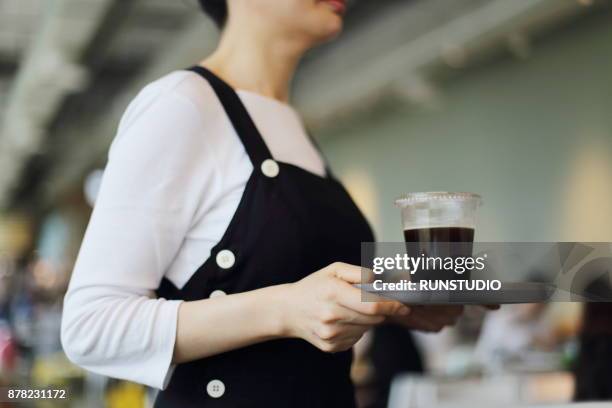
188, 65, 272, 164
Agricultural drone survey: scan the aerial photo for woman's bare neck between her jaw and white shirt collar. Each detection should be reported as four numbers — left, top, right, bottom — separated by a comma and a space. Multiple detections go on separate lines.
202, 23, 308, 102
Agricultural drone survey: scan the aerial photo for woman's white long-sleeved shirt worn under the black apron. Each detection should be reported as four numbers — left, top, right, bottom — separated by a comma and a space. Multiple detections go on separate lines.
62, 71, 325, 389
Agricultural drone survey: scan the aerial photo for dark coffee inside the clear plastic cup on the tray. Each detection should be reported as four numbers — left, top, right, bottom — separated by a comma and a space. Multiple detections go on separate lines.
404, 227, 474, 281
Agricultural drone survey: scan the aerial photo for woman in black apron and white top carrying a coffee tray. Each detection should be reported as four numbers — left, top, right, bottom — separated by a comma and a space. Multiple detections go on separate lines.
62, 0, 458, 407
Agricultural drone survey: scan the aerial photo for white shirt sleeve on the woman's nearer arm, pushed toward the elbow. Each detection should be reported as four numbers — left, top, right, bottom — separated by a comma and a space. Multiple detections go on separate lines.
62, 84, 219, 389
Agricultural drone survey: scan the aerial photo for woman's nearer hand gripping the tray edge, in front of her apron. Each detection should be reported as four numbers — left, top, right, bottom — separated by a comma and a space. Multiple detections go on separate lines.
281, 263, 410, 352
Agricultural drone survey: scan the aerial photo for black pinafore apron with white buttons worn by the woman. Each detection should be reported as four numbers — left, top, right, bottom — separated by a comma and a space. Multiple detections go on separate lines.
155, 66, 373, 408
